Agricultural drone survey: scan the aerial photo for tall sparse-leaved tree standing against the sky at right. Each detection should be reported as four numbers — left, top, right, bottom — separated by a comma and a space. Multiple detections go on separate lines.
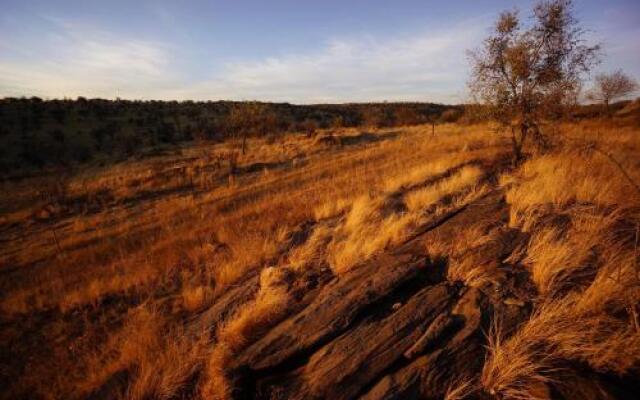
469, 0, 599, 162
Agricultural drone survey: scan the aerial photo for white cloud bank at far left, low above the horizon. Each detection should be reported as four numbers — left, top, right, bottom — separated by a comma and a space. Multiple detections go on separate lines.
0, 19, 174, 98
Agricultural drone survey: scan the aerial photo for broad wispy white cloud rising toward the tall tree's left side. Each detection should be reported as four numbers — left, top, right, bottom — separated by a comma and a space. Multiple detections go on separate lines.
176, 21, 480, 103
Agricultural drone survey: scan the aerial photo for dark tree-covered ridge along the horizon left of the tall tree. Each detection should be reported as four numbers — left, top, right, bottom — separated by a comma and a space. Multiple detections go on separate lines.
0, 97, 462, 175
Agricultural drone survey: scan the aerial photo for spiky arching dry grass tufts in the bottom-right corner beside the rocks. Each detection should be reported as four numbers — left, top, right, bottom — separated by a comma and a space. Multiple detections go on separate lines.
482, 296, 640, 399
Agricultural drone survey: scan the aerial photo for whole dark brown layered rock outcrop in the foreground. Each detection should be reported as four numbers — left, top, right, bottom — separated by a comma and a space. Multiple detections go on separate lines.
191, 192, 540, 399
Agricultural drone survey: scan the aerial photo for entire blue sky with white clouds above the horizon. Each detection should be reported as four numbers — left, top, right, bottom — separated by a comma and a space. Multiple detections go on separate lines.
0, 0, 640, 104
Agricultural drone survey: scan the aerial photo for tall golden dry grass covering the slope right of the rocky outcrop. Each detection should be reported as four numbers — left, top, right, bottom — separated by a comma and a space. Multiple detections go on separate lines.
482, 133, 640, 399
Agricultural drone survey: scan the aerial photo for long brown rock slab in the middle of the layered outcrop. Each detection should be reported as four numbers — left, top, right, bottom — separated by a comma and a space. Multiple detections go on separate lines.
279, 284, 454, 399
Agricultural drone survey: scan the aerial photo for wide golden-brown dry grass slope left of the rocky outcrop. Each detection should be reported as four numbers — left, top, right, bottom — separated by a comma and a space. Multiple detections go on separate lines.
0, 126, 504, 398
